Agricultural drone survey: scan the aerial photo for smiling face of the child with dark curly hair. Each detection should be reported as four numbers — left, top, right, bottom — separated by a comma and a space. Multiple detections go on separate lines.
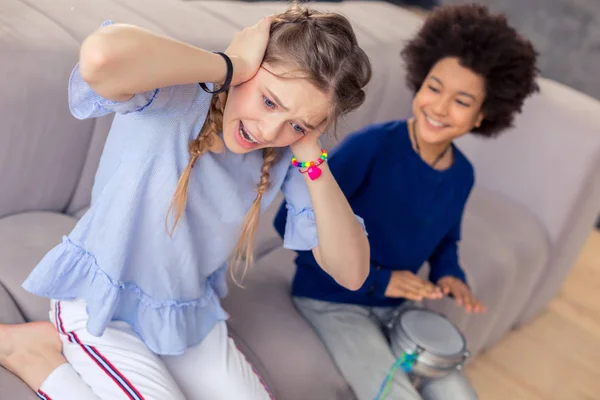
413, 57, 485, 145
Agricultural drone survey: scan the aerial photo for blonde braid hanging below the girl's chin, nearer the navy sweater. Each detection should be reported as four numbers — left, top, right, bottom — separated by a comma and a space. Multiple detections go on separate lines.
231, 148, 277, 284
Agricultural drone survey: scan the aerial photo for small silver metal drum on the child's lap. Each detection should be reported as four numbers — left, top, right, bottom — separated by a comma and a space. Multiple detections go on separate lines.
389, 307, 470, 379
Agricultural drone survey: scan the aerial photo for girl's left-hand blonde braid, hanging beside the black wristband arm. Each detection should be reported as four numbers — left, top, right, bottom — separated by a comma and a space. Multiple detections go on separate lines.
165, 94, 226, 236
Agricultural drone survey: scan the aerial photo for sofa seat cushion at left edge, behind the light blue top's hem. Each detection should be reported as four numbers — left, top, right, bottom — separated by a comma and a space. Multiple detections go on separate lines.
0, 212, 76, 321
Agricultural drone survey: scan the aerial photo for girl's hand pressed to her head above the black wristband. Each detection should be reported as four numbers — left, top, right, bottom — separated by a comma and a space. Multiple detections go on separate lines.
225, 16, 273, 86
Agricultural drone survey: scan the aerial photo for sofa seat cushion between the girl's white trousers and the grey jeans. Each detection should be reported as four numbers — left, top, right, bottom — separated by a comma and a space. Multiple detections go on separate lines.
223, 248, 354, 400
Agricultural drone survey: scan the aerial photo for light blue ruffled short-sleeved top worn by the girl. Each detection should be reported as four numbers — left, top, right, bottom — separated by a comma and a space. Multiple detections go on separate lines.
23, 55, 346, 354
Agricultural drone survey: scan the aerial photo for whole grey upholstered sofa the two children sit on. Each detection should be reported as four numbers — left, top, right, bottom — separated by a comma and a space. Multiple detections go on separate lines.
0, 0, 600, 400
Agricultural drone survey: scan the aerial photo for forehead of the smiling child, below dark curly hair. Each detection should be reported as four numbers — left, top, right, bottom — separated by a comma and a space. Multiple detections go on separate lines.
429, 57, 485, 94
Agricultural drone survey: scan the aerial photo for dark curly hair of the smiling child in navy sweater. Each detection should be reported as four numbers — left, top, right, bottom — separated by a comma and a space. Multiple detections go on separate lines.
401, 4, 539, 137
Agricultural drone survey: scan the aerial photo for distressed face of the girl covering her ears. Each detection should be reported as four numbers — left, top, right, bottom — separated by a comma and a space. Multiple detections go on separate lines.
223, 65, 331, 153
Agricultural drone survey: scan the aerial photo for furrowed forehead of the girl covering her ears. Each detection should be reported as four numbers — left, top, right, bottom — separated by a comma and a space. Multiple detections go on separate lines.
255, 65, 332, 126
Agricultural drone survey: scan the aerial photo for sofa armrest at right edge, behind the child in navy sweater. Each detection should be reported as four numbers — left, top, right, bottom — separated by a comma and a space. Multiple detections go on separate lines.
458, 79, 600, 320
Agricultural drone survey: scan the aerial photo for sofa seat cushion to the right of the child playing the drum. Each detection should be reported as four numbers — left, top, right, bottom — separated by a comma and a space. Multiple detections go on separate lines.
426, 187, 549, 353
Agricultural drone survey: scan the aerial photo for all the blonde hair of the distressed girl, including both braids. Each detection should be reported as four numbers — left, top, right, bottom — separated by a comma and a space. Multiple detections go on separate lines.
167, 4, 371, 280
